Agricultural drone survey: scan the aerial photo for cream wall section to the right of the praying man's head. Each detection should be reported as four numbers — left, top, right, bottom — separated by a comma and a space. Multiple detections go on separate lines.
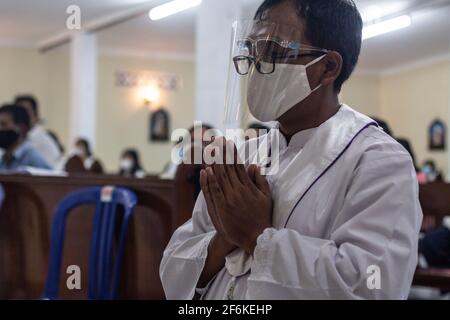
341, 61, 450, 178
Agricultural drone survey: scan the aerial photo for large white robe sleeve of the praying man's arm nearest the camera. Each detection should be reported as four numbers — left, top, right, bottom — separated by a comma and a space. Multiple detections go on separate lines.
247, 150, 422, 299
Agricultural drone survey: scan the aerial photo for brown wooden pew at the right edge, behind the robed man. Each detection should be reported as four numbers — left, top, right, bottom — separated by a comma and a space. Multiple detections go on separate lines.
413, 182, 450, 290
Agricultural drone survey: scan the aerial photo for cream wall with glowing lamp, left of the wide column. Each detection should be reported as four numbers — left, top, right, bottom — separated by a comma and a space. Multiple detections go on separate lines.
0, 47, 195, 173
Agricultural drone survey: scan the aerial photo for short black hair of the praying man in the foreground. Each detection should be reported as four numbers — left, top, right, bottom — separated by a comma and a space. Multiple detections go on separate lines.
255, 0, 363, 92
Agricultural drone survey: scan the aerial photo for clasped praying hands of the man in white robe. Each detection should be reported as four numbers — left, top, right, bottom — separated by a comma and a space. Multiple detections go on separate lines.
200, 137, 273, 254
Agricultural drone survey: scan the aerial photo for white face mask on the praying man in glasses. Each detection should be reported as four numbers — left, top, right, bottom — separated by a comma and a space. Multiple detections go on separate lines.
247, 55, 325, 122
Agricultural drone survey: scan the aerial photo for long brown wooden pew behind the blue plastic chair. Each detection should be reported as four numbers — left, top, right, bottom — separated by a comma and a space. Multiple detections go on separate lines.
0, 175, 192, 299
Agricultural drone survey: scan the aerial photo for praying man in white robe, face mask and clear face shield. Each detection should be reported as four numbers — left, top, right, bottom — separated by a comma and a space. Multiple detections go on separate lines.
160, 0, 422, 300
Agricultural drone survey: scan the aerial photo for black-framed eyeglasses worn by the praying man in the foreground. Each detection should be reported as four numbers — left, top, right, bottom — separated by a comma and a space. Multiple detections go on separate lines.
233, 52, 324, 76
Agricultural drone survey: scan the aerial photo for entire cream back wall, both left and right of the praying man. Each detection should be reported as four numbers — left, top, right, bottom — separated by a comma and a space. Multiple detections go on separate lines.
0, 47, 450, 178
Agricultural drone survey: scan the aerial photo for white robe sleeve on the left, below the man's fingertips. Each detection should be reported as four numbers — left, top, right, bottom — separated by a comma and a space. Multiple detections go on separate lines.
159, 193, 216, 300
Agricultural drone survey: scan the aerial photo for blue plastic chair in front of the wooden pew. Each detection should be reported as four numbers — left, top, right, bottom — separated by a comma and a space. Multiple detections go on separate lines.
44, 187, 137, 300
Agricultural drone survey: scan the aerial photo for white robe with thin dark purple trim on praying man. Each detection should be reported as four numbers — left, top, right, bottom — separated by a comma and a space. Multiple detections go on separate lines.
160, 105, 422, 300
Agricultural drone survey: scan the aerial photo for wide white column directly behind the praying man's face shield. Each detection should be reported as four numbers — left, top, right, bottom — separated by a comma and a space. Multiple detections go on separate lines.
195, 0, 245, 128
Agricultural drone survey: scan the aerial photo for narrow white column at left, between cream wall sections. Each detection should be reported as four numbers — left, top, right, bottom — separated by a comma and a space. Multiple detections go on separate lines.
69, 33, 97, 145
